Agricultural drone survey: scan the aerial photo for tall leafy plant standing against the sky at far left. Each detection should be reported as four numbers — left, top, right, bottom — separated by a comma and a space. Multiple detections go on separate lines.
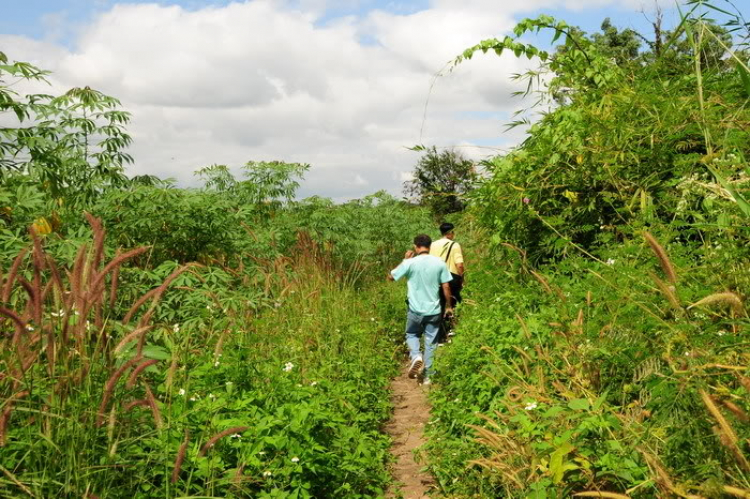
0, 52, 132, 206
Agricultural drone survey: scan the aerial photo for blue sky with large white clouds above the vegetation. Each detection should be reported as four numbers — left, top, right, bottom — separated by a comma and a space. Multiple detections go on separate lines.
0, 0, 674, 201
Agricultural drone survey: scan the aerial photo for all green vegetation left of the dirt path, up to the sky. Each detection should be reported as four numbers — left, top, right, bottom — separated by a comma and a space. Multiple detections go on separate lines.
0, 48, 440, 498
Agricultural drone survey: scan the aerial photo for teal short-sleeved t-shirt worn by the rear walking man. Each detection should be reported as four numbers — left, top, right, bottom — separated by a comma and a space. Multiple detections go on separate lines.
391, 255, 453, 315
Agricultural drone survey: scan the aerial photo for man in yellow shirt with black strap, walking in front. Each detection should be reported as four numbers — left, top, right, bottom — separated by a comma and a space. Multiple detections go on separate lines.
430, 222, 465, 343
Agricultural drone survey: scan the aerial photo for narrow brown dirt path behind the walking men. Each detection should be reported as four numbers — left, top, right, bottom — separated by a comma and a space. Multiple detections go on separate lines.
386, 366, 435, 499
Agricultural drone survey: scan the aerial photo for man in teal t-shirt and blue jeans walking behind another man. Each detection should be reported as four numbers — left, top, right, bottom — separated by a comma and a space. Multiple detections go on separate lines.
388, 234, 453, 385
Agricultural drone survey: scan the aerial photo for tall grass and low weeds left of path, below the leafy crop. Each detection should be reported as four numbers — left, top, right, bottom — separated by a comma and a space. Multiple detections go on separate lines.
0, 217, 414, 497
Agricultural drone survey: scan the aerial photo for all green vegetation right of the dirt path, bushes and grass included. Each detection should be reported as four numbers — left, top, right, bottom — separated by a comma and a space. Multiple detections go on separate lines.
430, 2, 750, 498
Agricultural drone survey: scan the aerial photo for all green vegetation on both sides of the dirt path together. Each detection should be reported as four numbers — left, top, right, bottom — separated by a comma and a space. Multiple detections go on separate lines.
0, 1, 750, 498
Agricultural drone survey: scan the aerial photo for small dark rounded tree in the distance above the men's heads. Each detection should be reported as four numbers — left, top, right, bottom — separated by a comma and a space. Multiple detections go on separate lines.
404, 146, 477, 215
